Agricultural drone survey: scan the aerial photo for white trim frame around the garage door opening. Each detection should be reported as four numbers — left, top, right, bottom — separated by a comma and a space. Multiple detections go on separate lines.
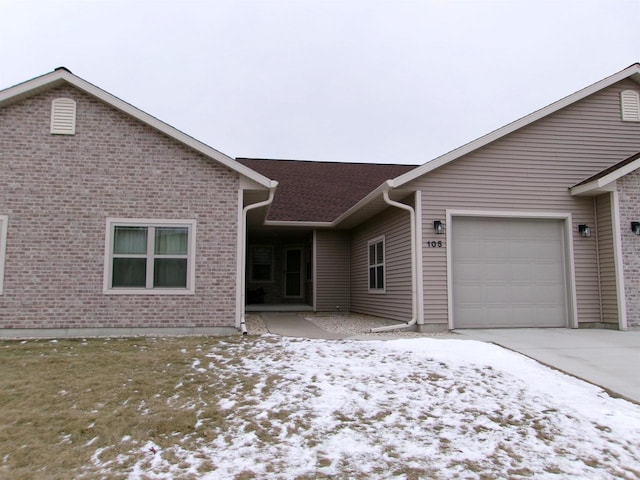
446, 209, 578, 329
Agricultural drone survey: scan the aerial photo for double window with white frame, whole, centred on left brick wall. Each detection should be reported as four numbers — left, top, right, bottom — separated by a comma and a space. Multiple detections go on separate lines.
104, 219, 196, 294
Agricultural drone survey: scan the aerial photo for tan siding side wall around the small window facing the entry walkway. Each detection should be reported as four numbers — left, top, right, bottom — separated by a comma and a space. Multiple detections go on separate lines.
351, 204, 412, 321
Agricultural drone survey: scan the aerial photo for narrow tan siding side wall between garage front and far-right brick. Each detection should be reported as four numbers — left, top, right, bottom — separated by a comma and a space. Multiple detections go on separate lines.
594, 193, 618, 324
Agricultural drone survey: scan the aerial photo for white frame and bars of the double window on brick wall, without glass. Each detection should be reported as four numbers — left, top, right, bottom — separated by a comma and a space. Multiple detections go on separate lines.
103, 218, 196, 295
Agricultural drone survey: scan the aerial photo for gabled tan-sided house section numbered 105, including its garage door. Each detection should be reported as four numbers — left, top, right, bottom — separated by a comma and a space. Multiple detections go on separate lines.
393, 65, 640, 328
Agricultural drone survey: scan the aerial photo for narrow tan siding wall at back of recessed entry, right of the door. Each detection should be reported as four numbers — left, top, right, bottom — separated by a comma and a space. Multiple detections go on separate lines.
315, 230, 351, 312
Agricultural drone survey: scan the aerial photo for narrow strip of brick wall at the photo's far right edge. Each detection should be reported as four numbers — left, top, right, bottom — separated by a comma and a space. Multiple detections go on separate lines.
617, 171, 640, 327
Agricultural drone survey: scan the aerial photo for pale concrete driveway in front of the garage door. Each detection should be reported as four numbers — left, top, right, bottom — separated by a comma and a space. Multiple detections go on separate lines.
455, 328, 640, 404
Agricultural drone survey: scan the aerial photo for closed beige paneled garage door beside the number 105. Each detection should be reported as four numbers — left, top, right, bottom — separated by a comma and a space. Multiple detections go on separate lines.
451, 217, 568, 328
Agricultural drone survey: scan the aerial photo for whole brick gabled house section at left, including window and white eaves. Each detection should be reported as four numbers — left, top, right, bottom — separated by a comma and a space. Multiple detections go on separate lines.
0, 70, 271, 336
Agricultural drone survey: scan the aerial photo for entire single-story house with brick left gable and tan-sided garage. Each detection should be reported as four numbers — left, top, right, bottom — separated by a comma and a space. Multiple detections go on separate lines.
0, 64, 640, 337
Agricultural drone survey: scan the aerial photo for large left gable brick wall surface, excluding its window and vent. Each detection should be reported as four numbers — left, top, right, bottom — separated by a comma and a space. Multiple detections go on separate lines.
0, 86, 239, 328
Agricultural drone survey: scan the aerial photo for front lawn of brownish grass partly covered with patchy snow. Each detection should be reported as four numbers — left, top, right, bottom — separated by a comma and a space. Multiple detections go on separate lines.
0, 335, 640, 479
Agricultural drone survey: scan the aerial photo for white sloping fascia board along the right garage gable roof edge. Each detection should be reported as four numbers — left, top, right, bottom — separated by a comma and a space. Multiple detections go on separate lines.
393, 63, 640, 187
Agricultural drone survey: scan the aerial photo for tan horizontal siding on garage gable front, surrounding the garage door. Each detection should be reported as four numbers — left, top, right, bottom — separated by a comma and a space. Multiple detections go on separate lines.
408, 80, 640, 323
